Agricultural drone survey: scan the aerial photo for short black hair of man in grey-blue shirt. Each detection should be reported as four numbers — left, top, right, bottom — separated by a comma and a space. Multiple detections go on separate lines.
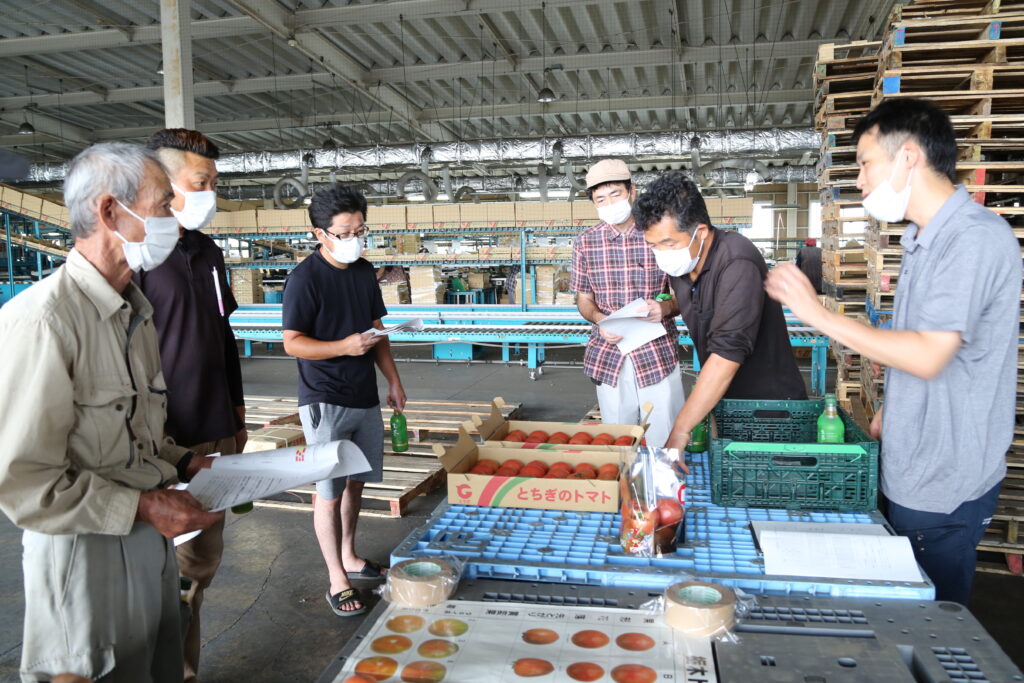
853, 97, 956, 182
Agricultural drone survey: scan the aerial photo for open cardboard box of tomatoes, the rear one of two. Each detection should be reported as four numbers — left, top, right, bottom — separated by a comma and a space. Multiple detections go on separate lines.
467, 396, 649, 454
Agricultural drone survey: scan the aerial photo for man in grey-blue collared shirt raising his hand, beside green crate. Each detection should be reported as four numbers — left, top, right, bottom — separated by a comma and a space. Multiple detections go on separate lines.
765, 99, 1021, 604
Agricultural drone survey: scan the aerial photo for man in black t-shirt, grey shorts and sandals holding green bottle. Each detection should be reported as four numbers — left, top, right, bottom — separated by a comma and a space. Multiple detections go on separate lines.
283, 184, 406, 616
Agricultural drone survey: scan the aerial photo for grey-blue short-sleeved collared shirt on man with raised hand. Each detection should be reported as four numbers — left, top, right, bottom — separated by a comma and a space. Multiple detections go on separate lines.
882, 186, 1021, 514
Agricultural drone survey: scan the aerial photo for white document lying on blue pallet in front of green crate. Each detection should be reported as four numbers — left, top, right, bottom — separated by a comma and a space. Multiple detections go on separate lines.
761, 529, 923, 582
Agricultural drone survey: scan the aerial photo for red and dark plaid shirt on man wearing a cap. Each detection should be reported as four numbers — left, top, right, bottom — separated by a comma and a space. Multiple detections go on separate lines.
569, 221, 679, 387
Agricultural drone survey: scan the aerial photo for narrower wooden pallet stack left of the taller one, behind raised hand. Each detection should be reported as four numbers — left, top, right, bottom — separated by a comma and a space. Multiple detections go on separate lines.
814, 41, 882, 410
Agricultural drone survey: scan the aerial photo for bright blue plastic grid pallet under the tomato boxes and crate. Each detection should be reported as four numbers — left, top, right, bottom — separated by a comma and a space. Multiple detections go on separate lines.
391, 455, 935, 600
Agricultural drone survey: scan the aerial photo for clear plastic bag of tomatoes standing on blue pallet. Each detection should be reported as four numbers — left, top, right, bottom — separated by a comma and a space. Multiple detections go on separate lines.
618, 446, 686, 557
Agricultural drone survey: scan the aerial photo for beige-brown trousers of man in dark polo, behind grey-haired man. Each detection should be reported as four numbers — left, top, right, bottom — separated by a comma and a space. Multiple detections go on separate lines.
177, 436, 237, 683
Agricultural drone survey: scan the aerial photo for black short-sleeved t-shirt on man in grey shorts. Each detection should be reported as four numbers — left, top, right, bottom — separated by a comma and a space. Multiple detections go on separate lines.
282, 250, 387, 409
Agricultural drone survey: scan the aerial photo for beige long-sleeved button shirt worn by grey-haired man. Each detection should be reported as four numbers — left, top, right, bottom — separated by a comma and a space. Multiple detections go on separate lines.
0, 249, 185, 536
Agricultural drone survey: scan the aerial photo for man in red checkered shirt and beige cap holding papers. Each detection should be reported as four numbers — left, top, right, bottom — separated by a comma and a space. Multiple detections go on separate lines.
570, 159, 684, 447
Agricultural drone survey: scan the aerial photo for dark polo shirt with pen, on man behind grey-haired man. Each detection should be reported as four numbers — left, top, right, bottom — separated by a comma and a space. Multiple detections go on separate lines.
132, 230, 245, 445
